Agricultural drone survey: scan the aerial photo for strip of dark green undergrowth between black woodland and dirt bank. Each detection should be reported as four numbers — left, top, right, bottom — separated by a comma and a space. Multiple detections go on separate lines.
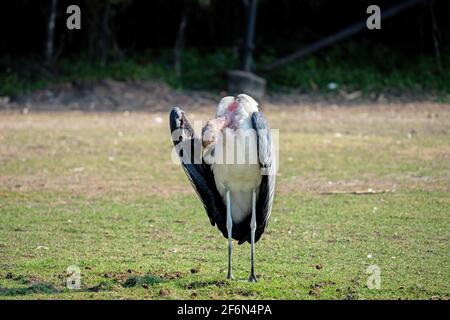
0, 42, 450, 101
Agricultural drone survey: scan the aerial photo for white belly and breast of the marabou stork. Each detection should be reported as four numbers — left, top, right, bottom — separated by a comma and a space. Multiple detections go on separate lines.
213, 129, 261, 223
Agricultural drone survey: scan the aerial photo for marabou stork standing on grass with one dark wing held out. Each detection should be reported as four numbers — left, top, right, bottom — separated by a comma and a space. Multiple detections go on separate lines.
170, 94, 276, 282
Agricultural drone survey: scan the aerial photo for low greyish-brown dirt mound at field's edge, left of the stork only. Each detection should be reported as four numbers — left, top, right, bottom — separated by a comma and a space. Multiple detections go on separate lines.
4, 80, 215, 111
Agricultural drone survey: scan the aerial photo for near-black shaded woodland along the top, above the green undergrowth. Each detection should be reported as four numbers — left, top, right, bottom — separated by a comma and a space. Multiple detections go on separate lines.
0, 0, 450, 66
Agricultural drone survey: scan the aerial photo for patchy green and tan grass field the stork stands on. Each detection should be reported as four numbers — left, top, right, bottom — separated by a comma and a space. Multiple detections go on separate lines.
0, 104, 450, 299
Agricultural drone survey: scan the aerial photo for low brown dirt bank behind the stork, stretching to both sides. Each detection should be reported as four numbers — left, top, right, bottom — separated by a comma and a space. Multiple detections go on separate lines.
0, 79, 446, 111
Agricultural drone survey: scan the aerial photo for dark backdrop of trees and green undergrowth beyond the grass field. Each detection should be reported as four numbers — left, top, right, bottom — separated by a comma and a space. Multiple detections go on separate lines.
0, 0, 450, 108
